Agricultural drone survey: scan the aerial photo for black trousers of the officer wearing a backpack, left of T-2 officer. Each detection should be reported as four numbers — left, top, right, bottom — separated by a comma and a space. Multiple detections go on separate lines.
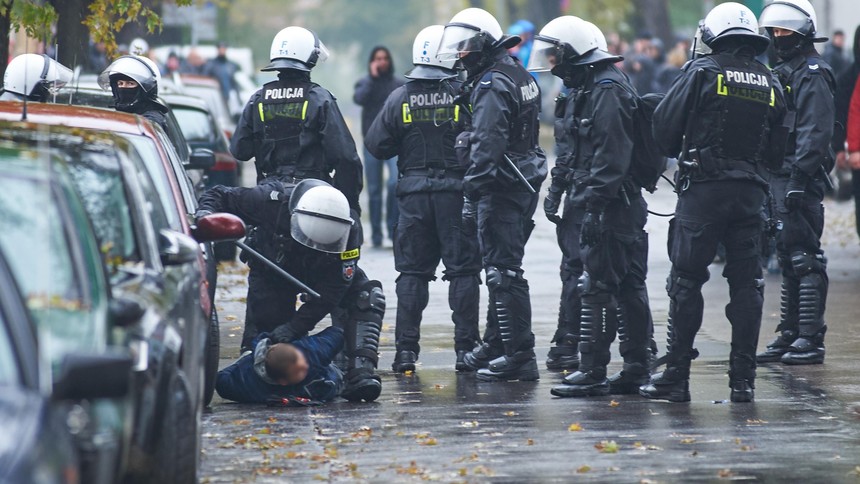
579, 197, 653, 372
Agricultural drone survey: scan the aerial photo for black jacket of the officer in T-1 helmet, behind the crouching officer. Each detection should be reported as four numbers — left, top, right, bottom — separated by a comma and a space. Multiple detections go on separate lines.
230, 70, 363, 212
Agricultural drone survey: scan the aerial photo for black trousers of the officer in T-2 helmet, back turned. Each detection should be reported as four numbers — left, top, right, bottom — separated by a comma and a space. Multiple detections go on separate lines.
667, 180, 767, 379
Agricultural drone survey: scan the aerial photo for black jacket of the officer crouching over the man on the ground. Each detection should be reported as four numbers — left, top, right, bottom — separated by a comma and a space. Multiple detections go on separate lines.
198, 178, 361, 331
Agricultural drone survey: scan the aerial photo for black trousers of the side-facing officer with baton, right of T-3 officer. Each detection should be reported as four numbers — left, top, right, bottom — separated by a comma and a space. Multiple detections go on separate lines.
477, 192, 539, 355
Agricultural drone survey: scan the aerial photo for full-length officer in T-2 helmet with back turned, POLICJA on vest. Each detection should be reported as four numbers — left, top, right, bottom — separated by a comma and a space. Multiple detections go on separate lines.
640, 2, 785, 402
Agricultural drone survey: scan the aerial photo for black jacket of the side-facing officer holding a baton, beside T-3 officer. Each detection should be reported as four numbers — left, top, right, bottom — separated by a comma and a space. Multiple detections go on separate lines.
463, 49, 547, 200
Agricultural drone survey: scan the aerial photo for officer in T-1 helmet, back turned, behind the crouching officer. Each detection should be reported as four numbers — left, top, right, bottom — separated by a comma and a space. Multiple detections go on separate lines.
230, 27, 362, 213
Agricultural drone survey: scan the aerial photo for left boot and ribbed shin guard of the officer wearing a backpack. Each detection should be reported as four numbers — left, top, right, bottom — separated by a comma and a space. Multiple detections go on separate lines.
550, 298, 609, 397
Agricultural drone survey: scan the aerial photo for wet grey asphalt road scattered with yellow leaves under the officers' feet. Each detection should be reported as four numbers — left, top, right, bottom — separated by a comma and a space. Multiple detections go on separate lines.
201, 172, 860, 482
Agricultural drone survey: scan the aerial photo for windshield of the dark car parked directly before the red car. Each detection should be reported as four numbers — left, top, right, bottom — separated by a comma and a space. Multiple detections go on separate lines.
66, 146, 141, 272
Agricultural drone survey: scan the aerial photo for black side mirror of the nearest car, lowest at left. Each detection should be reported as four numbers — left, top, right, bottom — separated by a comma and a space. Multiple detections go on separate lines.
51, 353, 132, 400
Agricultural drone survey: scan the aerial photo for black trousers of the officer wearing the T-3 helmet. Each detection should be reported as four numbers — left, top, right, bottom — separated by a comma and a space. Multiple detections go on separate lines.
394, 192, 481, 353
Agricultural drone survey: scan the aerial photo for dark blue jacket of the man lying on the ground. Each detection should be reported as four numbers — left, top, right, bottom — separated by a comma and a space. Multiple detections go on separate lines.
215, 326, 344, 403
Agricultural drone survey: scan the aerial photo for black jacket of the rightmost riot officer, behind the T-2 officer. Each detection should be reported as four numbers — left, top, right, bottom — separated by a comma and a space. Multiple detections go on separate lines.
774, 47, 836, 178
